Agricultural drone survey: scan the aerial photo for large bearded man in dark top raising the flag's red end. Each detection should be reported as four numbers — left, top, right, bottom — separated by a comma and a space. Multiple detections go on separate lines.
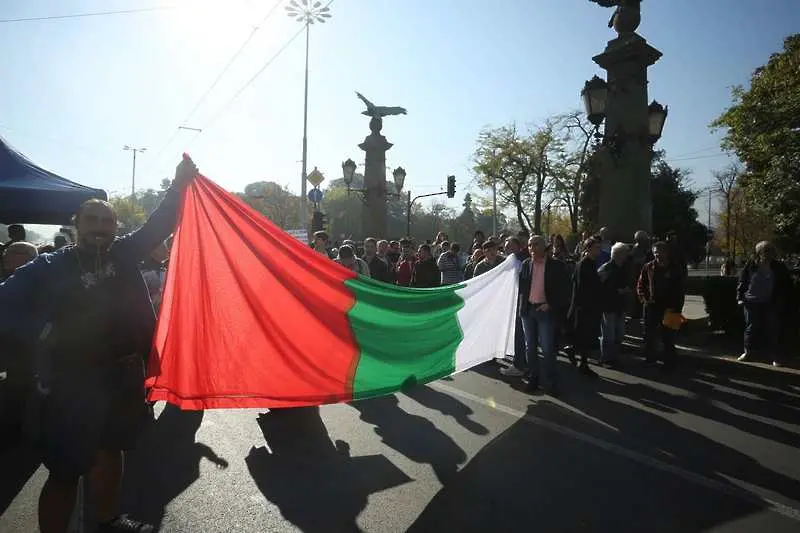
0, 158, 197, 533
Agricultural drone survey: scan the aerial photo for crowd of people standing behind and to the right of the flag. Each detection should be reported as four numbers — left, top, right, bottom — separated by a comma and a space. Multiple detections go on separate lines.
312, 224, 791, 394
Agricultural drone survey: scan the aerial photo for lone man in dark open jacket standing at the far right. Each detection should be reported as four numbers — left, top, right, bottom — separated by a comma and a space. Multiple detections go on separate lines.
736, 241, 794, 366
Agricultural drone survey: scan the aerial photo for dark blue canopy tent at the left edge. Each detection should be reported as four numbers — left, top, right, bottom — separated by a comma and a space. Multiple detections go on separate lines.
0, 137, 108, 224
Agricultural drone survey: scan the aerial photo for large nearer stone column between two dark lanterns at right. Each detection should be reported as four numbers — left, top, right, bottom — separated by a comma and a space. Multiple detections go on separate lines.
593, 0, 661, 242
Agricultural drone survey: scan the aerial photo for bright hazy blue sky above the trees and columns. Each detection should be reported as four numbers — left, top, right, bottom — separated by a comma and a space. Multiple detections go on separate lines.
0, 0, 800, 237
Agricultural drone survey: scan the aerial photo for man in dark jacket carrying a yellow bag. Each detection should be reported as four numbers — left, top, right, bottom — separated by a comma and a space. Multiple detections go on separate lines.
636, 241, 686, 370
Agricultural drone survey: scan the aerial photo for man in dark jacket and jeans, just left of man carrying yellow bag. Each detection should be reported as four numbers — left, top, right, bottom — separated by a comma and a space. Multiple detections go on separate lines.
598, 242, 631, 366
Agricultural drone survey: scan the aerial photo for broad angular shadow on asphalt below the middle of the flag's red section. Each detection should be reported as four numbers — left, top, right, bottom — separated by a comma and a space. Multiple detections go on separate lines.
245, 407, 411, 533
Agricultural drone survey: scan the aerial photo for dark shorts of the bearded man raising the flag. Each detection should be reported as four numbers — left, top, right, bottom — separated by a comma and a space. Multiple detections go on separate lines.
28, 358, 149, 479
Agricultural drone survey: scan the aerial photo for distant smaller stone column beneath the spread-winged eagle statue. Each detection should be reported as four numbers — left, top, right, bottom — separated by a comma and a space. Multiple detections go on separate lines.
358, 117, 392, 239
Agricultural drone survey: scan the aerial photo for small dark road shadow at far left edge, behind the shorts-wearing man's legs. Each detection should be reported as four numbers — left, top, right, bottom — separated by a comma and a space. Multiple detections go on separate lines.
0, 432, 41, 515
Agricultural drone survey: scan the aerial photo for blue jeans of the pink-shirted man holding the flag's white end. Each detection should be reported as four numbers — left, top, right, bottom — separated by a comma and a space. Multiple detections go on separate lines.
522, 309, 556, 390
